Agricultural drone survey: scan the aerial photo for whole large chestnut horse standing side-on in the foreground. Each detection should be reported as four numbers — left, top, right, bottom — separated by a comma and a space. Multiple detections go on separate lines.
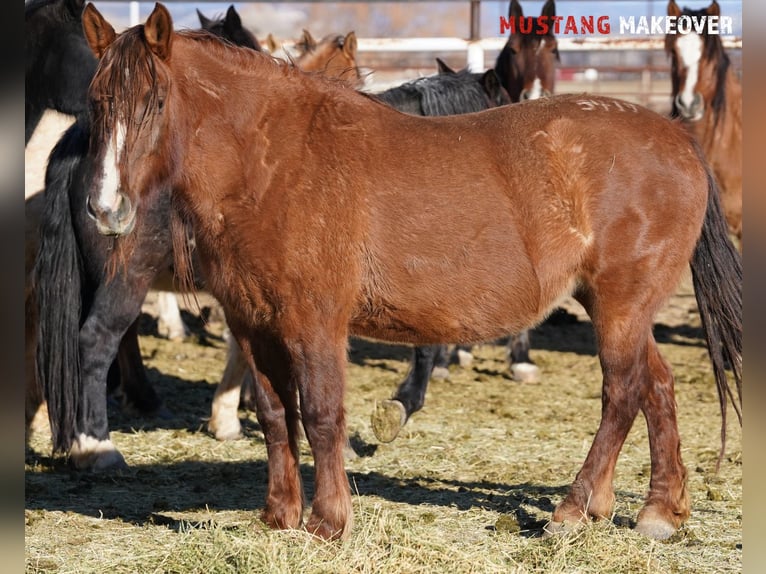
83, 3, 742, 539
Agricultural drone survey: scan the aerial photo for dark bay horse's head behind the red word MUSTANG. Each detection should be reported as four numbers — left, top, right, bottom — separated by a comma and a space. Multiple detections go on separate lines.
495, 0, 559, 102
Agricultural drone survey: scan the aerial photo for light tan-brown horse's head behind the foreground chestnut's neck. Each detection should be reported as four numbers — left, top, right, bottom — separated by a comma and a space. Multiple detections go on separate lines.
295, 30, 364, 87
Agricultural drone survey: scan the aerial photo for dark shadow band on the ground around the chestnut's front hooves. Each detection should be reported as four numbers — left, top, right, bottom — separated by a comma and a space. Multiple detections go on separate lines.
25, 455, 588, 537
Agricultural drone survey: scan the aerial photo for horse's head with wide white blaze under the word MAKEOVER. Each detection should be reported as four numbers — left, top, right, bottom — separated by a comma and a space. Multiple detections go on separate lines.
665, 0, 729, 122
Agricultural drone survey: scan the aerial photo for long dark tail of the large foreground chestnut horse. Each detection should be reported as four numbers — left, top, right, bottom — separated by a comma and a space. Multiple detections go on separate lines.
691, 161, 742, 468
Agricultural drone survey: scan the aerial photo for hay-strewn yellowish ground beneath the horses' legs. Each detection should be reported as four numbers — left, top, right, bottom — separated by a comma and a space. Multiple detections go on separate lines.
25, 276, 742, 574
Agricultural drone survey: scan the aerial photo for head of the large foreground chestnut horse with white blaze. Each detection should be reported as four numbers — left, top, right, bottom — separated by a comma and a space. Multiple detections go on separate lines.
83, 4, 174, 235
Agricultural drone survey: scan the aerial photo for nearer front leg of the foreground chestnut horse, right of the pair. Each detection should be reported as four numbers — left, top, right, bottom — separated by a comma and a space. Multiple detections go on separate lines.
292, 329, 353, 540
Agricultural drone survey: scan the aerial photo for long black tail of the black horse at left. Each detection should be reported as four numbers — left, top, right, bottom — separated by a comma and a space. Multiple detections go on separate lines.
34, 125, 87, 452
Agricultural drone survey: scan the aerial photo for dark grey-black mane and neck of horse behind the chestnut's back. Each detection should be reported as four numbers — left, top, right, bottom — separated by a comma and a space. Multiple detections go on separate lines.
377, 69, 498, 116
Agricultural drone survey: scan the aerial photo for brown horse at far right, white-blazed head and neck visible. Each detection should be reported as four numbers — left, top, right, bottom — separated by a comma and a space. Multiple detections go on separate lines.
665, 0, 742, 248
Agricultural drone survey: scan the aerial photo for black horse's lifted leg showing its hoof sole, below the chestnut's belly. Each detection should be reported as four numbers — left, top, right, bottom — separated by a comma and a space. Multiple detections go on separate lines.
372, 345, 446, 442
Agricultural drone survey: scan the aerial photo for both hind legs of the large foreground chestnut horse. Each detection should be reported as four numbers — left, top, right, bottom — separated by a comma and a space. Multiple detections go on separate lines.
549, 286, 689, 538
